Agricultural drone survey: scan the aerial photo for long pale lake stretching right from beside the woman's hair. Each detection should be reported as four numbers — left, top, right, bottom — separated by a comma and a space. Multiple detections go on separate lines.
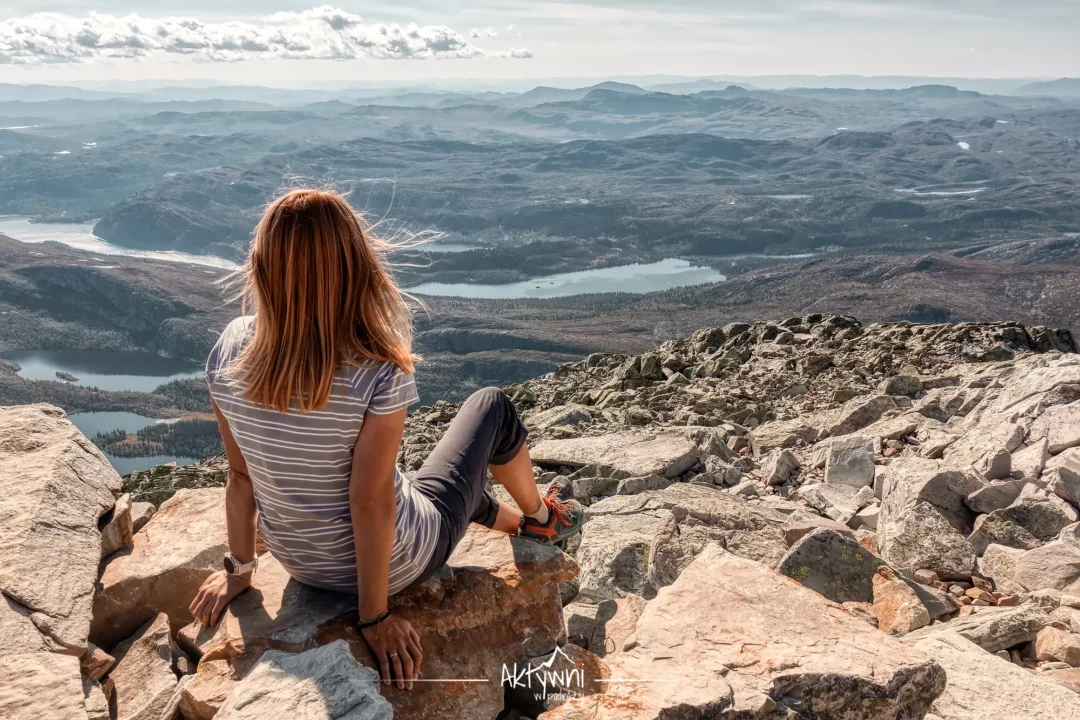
407, 258, 727, 299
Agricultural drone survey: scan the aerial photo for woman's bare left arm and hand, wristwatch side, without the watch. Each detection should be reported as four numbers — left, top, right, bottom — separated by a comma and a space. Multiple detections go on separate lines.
190, 399, 258, 625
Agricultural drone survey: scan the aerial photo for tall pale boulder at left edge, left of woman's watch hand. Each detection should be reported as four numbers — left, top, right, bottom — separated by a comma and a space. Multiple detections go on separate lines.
0, 405, 121, 655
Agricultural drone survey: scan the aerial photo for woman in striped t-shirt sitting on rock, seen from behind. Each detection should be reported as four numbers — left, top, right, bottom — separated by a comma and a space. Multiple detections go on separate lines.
191, 190, 582, 688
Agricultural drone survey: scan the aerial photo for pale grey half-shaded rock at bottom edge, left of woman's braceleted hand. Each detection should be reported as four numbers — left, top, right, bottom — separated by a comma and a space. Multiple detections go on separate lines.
215, 640, 393, 720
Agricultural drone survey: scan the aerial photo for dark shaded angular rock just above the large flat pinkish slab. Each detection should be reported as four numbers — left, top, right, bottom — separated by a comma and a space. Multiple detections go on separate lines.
777, 528, 883, 602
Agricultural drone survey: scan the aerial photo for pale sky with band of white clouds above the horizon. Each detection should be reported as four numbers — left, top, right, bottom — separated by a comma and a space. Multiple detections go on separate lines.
0, 0, 1080, 85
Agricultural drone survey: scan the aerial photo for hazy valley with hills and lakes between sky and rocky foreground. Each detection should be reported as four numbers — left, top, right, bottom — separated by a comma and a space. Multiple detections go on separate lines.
0, 78, 1080, 468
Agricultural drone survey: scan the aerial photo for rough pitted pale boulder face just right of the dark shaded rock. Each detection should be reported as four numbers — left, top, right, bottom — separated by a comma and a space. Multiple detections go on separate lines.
878, 499, 975, 579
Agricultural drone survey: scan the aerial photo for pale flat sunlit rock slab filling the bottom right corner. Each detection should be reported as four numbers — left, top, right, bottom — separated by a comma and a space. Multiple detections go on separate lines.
915, 631, 1080, 720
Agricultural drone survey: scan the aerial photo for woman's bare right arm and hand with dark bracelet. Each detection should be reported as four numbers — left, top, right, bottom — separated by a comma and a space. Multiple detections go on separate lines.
349, 408, 422, 688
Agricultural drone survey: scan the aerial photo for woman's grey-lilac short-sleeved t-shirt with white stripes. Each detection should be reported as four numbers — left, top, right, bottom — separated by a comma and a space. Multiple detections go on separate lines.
206, 316, 440, 594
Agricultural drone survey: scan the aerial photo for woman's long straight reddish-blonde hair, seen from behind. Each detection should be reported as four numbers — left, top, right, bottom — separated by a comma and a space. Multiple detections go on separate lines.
229, 189, 417, 412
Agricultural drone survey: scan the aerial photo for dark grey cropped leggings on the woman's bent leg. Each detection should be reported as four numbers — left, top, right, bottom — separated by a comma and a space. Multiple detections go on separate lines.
413, 388, 528, 585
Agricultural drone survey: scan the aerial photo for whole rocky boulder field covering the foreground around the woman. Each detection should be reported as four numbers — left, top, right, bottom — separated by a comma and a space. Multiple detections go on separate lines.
6, 315, 1080, 720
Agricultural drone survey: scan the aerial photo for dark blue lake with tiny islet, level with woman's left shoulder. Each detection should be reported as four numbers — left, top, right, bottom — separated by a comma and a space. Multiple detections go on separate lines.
0, 350, 203, 393
